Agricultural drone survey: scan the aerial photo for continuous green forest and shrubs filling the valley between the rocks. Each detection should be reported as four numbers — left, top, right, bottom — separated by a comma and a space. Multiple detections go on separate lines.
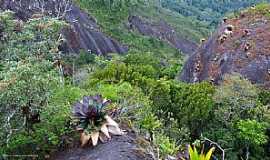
0, 0, 270, 160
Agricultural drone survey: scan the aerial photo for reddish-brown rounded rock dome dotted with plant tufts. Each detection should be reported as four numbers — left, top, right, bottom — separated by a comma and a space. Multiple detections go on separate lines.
180, 8, 270, 88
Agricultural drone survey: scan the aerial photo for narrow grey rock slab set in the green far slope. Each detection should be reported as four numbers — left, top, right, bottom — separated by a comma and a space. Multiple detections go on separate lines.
129, 16, 198, 54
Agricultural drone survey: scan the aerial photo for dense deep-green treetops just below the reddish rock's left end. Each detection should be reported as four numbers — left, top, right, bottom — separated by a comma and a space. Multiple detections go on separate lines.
150, 80, 214, 138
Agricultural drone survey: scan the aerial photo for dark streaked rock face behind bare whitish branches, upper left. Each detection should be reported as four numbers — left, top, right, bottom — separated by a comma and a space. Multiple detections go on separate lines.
0, 0, 127, 55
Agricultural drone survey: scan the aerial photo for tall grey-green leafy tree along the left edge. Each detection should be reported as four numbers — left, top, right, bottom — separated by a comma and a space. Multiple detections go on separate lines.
0, 11, 65, 149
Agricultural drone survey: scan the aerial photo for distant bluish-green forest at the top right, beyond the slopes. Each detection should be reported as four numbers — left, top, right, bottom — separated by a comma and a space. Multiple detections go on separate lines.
161, 0, 270, 29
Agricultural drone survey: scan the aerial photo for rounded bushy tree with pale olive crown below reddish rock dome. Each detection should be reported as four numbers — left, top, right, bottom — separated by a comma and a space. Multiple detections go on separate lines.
204, 75, 267, 159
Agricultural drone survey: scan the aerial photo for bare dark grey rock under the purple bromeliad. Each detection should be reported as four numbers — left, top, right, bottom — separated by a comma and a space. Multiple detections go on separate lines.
51, 134, 154, 160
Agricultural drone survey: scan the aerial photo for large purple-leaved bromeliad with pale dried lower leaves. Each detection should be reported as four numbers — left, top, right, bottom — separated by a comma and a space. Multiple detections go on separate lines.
73, 95, 124, 146
